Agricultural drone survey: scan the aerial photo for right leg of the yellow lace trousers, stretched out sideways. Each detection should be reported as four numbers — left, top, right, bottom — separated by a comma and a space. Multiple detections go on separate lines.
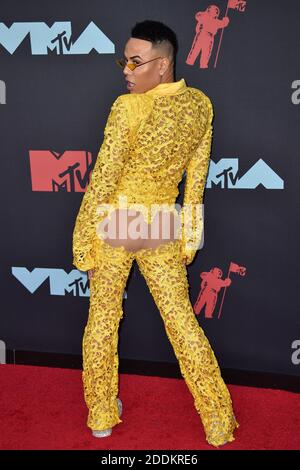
136, 240, 237, 445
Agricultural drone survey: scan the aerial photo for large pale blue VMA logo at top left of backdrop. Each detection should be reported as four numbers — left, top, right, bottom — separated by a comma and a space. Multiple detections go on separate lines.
0, 21, 115, 55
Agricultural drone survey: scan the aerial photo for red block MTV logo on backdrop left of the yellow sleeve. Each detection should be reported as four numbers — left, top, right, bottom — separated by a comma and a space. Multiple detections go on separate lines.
29, 150, 92, 193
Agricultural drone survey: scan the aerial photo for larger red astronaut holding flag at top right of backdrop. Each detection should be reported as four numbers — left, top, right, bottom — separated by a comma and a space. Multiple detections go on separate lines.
186, 0, 247, 69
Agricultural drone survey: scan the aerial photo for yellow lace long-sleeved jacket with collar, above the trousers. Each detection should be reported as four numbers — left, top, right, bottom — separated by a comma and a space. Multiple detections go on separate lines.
73, 78, 213, 271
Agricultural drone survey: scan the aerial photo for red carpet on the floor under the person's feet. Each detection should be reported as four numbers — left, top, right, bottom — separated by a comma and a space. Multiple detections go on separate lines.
0, 365, 300, 450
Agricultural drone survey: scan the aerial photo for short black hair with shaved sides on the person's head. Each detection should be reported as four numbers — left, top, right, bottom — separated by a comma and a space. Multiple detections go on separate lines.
131, 20, 178, 73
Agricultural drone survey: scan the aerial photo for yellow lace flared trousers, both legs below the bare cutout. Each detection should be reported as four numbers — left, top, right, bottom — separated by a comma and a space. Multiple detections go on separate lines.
82, 238, 239, 446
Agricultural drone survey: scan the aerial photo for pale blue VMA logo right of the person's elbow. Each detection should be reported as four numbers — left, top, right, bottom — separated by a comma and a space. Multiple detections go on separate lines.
206, 158, 284, 189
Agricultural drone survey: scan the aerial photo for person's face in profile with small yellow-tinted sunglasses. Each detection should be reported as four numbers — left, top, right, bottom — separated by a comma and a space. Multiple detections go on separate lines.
123, 38, 162, 93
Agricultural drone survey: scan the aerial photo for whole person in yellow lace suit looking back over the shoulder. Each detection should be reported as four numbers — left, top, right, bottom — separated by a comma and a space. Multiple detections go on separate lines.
73, 20, 238, 446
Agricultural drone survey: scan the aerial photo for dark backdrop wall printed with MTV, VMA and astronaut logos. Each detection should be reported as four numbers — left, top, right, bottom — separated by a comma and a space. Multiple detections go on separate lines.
0, 0, 300, 375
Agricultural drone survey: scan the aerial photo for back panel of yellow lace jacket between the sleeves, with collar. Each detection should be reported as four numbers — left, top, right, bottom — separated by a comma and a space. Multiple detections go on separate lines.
109, 79, 211, 204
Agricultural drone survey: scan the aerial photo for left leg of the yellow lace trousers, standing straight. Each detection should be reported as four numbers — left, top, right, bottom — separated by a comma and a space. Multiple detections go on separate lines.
82, 240, 133, 430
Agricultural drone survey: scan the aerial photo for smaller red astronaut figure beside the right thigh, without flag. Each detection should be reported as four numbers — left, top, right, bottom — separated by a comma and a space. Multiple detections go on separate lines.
194, 268, 231, 318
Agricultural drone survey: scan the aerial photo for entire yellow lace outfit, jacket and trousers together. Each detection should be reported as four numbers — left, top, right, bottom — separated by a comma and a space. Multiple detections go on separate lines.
73, 79, 238, 446
